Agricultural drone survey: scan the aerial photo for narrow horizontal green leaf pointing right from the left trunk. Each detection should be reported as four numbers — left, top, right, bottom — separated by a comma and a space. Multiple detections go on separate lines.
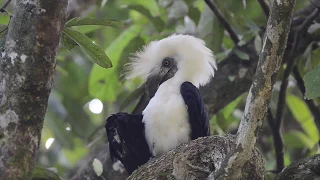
65, 17, 123, 29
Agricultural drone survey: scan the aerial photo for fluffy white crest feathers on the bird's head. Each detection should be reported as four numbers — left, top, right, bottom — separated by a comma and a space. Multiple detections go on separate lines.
126, 35, 217, 87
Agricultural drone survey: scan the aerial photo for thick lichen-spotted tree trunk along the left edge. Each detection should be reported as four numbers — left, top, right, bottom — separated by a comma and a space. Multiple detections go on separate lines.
0, 0, 68, 180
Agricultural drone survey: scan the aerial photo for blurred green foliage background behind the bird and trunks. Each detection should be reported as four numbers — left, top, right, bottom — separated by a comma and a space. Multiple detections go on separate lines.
0, 0, 320, 177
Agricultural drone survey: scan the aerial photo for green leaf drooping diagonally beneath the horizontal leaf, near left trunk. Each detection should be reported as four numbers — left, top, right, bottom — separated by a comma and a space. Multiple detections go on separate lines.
63, 27, 112, 68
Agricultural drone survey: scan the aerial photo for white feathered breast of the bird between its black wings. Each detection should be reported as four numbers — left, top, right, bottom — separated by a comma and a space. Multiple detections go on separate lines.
143, 81, 190, 156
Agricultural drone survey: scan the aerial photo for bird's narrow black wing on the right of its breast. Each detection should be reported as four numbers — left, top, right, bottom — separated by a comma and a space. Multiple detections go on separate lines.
180, 82, 210, 140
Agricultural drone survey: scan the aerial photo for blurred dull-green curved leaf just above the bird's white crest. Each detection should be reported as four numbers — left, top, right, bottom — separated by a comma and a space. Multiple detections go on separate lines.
128, 5, 164, 31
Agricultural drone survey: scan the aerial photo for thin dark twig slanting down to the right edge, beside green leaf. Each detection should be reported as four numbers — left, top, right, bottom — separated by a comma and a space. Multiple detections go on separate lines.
293, 66, 320, 134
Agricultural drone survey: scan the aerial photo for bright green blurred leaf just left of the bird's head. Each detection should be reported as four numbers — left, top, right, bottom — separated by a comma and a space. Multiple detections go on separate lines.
89, 25, 142, 101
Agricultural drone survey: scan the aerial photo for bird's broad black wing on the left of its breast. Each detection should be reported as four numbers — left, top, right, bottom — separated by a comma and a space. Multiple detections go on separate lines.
105, 113, 151, 174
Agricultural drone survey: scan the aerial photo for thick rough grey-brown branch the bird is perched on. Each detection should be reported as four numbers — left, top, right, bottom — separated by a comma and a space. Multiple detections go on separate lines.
128, 135, 264, 180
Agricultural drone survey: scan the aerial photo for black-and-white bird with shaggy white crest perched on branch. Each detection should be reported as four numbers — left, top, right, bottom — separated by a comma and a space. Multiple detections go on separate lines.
105, 34, 217, 174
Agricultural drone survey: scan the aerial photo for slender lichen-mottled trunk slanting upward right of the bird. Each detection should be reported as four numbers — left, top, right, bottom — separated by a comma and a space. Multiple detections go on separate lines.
208, 0, 295, 180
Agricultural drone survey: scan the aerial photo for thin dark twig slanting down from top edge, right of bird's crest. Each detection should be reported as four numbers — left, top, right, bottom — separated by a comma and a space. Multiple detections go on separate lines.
204, 0, 240, 46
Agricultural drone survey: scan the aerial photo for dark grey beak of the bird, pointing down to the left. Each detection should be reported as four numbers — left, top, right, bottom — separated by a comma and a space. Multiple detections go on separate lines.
146, 65, 178, 99
